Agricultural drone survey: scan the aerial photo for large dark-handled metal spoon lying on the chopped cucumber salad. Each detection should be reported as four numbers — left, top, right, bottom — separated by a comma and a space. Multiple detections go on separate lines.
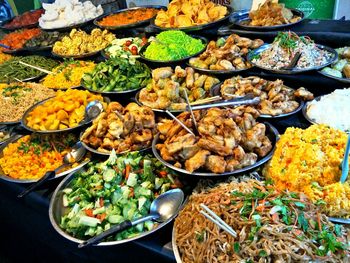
78, 189, 184, 248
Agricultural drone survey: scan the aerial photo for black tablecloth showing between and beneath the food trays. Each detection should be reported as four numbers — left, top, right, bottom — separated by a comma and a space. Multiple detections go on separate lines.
0, 20, 350, 262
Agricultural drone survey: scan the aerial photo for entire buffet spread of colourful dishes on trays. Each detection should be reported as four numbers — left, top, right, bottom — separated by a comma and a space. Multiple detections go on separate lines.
0, 0, 350, 263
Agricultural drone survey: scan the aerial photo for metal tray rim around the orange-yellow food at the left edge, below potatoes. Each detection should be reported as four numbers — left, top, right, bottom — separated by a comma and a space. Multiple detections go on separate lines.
0, 135, 89, 184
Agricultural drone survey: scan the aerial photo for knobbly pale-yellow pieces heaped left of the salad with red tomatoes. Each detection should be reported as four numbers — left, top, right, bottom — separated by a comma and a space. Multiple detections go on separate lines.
53, 28, 115, 56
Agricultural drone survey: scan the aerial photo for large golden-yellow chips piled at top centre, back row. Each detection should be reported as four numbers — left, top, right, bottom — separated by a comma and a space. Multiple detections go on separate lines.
154, 0, 228, 28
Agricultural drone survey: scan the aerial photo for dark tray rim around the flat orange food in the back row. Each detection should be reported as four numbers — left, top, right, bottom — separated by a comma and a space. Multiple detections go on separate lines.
94, 5, 166, 30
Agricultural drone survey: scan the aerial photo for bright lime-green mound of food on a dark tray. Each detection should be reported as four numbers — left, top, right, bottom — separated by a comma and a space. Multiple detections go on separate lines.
143, 30, 206, 61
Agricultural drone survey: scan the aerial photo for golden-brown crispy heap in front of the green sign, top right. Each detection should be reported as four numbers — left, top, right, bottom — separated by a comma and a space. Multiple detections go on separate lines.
247, 0, 301, 27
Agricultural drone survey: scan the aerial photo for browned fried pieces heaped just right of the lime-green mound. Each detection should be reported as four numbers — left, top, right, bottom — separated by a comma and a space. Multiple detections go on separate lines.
189, 34, 264, 71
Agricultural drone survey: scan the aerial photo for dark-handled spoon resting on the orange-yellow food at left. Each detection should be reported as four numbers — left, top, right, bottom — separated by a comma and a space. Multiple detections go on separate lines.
17, 142, 86, 198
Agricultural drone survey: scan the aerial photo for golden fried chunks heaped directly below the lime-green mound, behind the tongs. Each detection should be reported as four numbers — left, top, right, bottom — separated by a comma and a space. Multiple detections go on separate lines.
138, 66, 220, 110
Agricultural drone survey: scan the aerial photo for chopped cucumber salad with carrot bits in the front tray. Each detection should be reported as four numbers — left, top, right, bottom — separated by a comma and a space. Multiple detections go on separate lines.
60, 151, 181, 241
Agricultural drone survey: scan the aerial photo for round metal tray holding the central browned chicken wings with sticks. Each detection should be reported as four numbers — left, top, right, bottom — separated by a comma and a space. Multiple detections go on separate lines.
152, 122, 279, 178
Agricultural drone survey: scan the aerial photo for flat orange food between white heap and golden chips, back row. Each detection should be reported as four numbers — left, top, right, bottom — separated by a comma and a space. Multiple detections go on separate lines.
98, 8, 159, 26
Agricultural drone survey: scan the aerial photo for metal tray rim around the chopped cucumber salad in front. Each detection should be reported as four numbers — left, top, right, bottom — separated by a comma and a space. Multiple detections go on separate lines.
49, 168, 177, 246
